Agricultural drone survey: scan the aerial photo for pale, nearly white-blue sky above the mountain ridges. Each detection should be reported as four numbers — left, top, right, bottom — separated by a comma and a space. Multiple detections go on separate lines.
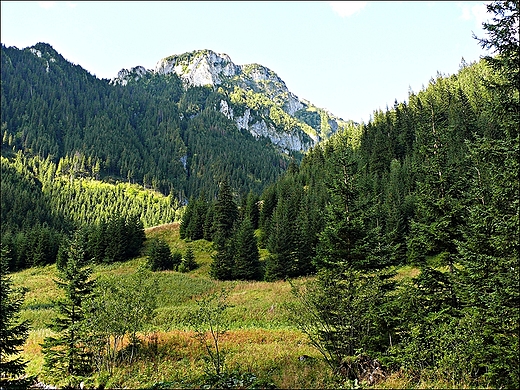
1, 1, 489, 122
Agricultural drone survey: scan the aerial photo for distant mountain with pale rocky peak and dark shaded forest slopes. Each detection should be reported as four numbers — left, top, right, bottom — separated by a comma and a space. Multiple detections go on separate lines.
1, 43, 350, 202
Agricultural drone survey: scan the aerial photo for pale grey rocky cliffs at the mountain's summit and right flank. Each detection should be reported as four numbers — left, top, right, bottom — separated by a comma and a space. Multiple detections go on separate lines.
111, 50, 345, 151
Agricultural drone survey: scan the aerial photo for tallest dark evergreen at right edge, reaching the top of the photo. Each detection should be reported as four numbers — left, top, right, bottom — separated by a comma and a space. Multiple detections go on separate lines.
459, 1, 520, 388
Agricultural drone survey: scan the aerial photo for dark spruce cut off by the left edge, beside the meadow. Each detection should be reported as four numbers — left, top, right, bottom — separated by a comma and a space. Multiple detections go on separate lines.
0, 245, 29, 387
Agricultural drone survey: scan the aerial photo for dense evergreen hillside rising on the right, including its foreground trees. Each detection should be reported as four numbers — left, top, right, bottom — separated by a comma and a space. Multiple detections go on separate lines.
183, 2, 520, 388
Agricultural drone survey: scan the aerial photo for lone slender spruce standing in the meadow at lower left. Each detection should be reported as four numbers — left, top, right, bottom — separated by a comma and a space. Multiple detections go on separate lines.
42, 234, 94, 386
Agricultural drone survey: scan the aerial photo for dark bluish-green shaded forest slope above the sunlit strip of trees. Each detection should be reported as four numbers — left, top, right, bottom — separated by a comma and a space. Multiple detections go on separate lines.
0, 43, 288, 202
